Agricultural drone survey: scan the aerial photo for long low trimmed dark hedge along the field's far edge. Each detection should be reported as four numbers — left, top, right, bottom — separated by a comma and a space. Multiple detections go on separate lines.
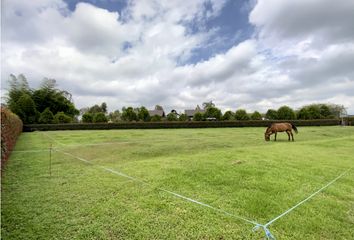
23, 119, 340, 132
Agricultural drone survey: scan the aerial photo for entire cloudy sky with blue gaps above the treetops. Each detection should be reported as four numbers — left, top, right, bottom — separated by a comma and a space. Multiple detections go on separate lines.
1, 0, 354, 114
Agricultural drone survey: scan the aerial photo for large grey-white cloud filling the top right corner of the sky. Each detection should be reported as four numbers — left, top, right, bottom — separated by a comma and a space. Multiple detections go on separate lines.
249, 0, 354, 47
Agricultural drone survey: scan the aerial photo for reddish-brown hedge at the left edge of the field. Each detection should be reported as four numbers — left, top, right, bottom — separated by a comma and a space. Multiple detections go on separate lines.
1, 107, 22, 169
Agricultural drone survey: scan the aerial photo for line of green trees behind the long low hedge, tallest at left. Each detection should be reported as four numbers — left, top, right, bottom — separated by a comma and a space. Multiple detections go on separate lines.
6, 74, 345, 124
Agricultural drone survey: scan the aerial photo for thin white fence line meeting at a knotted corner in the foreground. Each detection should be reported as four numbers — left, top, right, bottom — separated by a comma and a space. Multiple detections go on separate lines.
54, 149, 352, 240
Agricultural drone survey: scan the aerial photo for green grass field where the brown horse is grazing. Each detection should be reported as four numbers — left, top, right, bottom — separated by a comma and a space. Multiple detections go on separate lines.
1, 127, 354, 239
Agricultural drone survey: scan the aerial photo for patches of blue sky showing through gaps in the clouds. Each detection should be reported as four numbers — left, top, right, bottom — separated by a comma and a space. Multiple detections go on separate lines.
65, 0, 253, 64
